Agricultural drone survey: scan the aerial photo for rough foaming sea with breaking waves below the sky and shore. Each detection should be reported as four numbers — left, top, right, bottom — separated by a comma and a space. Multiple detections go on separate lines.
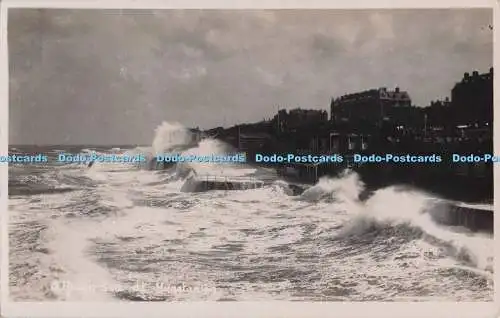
8, 122, 494, 301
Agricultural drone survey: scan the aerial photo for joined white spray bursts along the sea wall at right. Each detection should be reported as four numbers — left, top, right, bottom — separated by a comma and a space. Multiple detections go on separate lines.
298, 171, 493, 271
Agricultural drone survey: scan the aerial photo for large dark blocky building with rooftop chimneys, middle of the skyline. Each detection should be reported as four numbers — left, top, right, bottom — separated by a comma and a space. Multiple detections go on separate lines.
330, 87, 411, 126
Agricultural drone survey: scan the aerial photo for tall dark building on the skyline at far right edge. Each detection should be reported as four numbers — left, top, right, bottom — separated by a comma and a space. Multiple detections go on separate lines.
451, 68, 493, 127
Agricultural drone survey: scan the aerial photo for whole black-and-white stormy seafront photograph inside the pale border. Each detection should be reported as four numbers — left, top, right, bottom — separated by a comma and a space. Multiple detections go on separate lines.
7, 8, 500, 302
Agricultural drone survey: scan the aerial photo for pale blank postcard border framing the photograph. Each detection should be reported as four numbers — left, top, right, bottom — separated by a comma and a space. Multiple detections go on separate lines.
0, 0, 500, 318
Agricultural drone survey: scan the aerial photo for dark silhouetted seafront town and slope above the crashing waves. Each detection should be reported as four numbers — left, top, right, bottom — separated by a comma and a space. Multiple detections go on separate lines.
197, 68, 493, 201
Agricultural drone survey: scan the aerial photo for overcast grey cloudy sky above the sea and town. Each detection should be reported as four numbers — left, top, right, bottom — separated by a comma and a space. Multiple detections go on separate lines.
8, 9, 493, 144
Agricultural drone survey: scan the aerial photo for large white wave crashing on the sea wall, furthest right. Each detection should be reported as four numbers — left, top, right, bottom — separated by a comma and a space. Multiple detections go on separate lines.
337, 186, 493, 271
